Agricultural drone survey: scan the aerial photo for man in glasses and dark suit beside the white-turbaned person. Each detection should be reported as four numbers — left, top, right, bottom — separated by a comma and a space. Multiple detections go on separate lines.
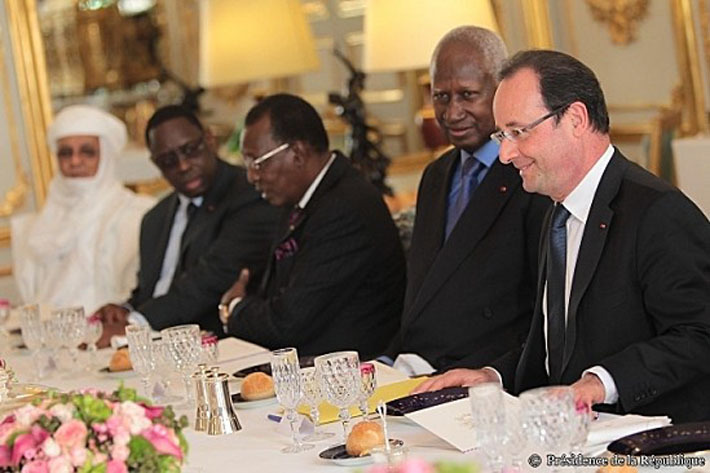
98, 105, 278, 345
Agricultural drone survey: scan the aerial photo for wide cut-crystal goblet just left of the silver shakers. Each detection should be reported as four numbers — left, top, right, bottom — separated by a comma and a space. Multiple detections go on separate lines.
160, 324, 202, 407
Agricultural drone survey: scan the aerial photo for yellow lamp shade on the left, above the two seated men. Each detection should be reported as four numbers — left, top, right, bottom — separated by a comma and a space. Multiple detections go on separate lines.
200, 0, 319, 87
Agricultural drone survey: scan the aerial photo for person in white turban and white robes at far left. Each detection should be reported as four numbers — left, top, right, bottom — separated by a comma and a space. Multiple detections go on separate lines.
11, 105, 155, 314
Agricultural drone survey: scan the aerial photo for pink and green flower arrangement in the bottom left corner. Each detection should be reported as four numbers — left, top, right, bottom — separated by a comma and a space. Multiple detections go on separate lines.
0, 386, 187, 473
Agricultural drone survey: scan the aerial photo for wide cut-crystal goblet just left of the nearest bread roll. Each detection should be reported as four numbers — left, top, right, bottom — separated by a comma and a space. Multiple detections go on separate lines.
315, 351, 362, 442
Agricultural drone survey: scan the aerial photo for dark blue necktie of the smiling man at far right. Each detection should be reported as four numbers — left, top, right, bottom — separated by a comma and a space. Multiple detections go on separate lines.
547, 204, 570, 384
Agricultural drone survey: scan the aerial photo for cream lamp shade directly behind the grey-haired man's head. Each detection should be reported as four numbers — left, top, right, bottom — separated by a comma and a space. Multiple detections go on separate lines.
363, 0, 498, 72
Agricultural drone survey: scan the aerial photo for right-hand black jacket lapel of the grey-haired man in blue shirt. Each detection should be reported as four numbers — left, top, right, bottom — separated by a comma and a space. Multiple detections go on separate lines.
409, 160, 520, 319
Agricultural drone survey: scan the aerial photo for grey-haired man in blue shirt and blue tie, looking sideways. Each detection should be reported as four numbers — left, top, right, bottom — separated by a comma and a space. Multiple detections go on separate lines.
383, 26, 550, 375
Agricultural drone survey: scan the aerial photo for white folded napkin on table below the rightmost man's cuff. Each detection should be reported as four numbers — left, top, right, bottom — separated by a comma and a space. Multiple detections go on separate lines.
585, 413, 671, 454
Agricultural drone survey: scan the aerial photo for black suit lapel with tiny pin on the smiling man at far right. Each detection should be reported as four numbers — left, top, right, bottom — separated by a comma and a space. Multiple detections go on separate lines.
564, 151, 627, 372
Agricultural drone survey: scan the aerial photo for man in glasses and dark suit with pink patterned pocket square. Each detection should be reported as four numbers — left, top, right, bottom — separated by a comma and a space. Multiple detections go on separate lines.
220, 94, 405, 359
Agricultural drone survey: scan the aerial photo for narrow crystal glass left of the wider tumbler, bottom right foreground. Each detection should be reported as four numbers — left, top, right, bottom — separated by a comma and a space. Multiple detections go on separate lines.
468, 383, 506, 471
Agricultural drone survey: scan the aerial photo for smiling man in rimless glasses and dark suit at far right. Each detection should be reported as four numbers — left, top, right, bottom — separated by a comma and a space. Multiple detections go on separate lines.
412, 51, 710, 423
